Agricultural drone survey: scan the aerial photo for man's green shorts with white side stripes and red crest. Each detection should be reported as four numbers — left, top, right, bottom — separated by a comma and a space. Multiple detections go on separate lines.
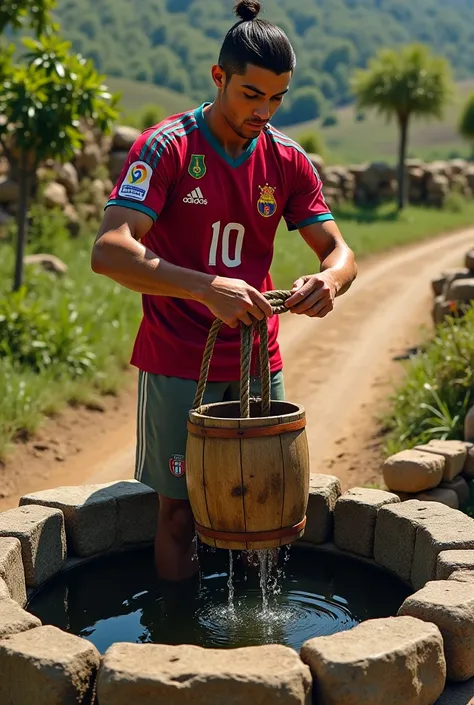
135, 371, 285, 499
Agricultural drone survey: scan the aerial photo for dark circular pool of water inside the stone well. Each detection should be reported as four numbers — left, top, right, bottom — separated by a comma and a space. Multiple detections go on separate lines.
27, 546, 410, 653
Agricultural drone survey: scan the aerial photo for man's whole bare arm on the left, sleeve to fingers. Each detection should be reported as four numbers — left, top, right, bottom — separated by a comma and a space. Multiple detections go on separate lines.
91, 206, 272, 328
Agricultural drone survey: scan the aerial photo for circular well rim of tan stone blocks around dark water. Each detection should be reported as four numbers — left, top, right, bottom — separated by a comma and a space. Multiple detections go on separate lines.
0, 475, 474, 705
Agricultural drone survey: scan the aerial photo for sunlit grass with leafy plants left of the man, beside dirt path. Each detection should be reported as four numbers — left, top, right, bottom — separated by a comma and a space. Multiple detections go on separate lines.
0, 216, 141, 458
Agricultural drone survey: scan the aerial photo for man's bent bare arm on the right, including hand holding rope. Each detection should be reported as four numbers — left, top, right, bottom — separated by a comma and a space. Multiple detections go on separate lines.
286, 220, 357, 318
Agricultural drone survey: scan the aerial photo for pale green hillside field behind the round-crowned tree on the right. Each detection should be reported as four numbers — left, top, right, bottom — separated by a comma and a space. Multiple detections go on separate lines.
282, 80, 474, 164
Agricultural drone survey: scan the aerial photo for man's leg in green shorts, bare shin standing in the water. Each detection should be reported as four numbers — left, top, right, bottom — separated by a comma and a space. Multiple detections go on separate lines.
135, 372, 227, 581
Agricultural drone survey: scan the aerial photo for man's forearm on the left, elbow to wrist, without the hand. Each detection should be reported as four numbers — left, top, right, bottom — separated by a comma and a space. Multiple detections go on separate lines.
91, 231, 211, 299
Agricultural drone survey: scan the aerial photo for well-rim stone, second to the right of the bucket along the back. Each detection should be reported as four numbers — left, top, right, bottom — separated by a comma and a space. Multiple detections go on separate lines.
334, 487, 400, 558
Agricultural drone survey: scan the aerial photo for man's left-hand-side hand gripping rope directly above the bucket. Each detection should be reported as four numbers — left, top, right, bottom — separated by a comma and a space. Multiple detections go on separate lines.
196, 277, 273, 328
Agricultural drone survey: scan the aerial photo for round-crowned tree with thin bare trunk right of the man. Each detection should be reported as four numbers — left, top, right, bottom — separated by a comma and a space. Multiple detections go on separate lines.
353, 44, 451, 209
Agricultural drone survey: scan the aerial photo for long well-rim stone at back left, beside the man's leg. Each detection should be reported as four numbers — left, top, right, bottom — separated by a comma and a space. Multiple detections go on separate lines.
20, 480, 158, 557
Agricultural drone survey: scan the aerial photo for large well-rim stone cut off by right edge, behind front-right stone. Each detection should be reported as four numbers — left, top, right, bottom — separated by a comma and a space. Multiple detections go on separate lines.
398, 580, 474, 681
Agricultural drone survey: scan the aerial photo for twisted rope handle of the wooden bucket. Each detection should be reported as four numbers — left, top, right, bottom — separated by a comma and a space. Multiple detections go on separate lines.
193, 290, 291, 418
